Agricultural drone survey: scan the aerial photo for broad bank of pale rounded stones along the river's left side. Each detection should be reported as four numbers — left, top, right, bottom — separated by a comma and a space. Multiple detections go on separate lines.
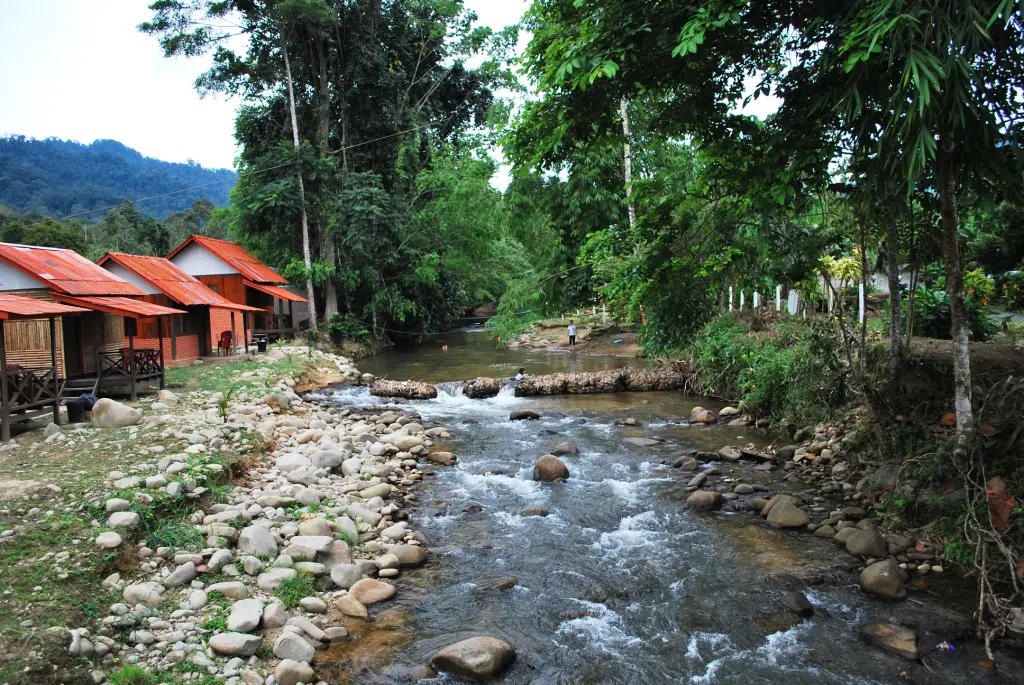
46, 350, 514, 685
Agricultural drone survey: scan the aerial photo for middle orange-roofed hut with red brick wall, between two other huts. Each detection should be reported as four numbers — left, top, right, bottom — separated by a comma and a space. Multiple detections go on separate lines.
96, 252, 263, 367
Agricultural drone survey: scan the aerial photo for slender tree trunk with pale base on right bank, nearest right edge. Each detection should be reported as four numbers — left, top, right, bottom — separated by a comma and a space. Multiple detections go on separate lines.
938, 135, 974, 441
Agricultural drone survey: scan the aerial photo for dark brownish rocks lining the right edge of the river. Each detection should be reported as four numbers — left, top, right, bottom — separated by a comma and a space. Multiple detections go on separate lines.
667, 408, 945, 658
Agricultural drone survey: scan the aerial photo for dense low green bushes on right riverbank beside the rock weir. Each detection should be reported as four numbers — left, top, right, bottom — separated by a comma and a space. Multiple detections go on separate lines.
690, 314, 846, 424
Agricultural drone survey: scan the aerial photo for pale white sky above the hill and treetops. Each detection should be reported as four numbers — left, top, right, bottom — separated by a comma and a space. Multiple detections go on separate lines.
0, 0, 528, 168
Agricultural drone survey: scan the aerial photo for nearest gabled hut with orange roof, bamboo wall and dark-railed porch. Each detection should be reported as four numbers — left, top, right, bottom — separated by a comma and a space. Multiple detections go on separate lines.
0, 243, 185, 398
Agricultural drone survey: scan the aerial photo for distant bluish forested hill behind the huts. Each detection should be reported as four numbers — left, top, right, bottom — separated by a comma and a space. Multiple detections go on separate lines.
0, 136, 236, 219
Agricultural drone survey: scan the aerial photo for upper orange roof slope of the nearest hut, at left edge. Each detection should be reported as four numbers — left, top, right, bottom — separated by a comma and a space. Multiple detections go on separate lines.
0, 243, 142, 295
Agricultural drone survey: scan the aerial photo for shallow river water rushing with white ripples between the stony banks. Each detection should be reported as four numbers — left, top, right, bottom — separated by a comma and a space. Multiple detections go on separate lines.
315, 327, 1019, 685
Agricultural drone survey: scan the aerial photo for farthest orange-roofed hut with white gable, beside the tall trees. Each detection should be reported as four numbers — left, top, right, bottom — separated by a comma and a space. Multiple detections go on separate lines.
167, 236, 306, 339
